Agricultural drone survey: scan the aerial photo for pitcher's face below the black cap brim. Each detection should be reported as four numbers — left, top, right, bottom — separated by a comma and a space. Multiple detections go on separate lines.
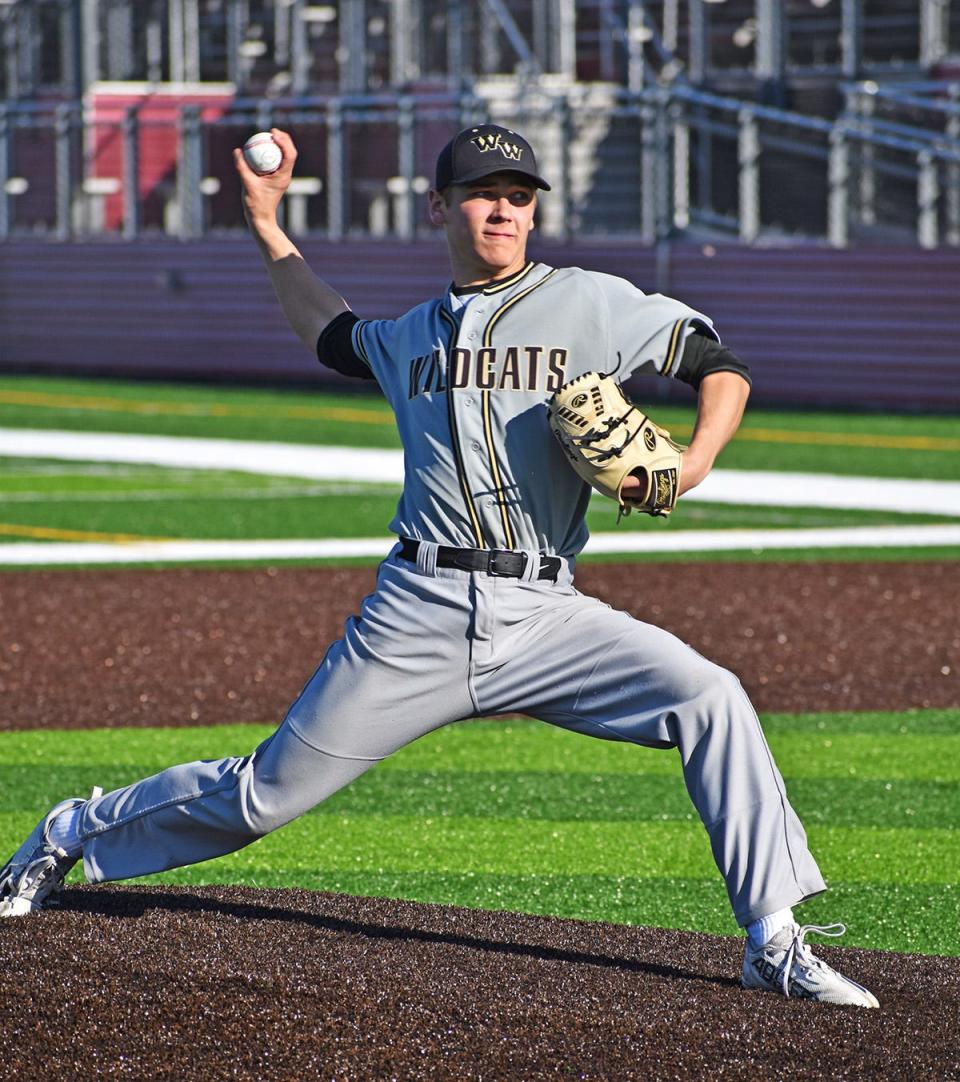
431, 173, 537, 286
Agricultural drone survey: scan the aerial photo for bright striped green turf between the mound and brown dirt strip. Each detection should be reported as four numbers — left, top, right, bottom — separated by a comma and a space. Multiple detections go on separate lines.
0, 711, 960, 954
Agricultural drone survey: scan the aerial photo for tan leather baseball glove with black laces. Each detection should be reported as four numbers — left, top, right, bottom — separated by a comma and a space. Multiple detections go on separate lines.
548, 372, 685, 515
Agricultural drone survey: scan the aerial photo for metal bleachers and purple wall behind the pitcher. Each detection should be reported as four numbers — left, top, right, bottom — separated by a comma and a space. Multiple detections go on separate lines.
0, 0, 960, 408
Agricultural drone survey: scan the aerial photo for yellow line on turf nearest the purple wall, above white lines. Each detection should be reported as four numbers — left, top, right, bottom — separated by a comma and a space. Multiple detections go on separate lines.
0, 391, 960, 451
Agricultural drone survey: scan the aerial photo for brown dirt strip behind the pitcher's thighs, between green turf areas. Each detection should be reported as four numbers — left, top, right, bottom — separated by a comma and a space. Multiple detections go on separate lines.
0, 560, 960, 729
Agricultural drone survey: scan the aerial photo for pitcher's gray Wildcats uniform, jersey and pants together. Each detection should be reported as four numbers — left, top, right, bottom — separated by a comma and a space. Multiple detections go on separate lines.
71, 257, 825, 924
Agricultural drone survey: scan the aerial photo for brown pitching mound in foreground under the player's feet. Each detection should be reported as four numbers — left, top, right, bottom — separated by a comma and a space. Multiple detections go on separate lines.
0, 887, 960, 1082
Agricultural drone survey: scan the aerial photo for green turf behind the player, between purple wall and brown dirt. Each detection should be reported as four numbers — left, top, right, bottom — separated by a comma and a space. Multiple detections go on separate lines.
0, 377, 960, 559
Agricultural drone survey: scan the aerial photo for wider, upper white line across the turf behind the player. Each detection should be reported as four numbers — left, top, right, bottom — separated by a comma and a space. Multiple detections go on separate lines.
0, 428, 960, 517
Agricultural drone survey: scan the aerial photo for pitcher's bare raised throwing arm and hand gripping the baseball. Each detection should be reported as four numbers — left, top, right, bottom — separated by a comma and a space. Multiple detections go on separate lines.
234, 128, 350, 356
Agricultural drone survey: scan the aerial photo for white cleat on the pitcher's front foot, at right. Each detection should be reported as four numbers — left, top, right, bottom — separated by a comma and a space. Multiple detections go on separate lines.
740, 924, 880, 1007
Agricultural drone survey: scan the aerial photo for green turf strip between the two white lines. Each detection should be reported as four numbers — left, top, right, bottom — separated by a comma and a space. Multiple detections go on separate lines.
0, 458, 956, 541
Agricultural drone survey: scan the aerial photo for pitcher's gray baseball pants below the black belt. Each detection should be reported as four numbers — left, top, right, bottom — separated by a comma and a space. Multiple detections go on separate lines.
80, 544, 826, 925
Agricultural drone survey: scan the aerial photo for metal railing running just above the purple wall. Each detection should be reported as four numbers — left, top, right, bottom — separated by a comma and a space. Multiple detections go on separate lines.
0, 83, 960, 248
